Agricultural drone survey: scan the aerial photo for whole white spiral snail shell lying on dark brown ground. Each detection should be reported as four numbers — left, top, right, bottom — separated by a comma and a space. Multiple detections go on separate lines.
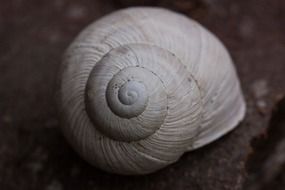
59, 8, 245, 174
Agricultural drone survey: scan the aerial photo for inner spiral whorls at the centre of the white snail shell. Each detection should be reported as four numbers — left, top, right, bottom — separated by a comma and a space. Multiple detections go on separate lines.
85, 44, 202, 155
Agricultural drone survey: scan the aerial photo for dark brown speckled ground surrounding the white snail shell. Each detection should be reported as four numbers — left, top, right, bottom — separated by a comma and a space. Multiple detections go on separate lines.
0, 0, 285, 190
